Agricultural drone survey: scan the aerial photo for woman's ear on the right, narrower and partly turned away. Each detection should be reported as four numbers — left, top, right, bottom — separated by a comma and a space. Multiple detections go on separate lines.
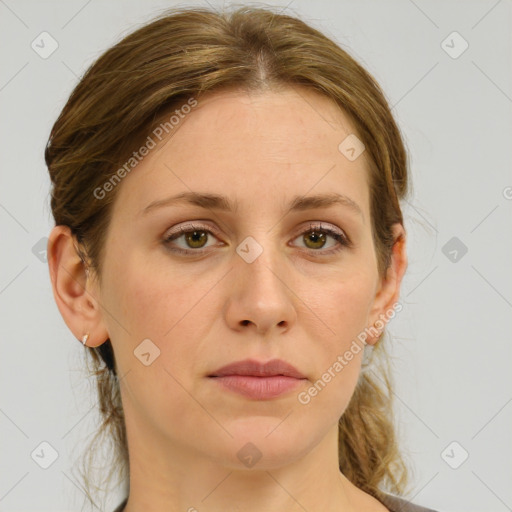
367, 223, 407, 345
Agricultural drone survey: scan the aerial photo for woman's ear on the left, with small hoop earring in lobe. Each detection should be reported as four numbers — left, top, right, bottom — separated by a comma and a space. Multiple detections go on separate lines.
47, 226, 109, 347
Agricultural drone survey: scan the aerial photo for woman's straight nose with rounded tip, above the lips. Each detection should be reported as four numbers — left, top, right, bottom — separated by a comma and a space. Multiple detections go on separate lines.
225, 244, 299, 337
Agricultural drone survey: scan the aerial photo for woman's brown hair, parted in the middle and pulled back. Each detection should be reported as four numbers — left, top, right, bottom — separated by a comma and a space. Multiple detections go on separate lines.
45, 6, 408, 512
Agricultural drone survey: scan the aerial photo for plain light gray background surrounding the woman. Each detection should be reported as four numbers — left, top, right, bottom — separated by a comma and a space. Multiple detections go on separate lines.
0, 0, 512, 512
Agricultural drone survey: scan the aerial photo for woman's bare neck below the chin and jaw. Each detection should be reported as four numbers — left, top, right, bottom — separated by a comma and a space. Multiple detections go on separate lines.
124, 425, 370, 512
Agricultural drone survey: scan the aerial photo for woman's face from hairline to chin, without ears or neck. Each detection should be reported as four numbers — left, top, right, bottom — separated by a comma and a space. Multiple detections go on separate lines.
91, 89, 404, 467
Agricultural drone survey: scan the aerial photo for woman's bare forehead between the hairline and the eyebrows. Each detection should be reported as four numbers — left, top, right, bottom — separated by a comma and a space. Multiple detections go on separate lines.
110, 87, 368, 220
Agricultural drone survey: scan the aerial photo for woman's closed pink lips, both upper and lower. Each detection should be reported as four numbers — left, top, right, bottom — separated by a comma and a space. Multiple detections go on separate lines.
208, 359, 306, 400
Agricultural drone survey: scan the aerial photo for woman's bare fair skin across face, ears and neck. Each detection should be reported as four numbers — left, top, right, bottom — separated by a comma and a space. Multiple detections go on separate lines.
48, 88, 407, 512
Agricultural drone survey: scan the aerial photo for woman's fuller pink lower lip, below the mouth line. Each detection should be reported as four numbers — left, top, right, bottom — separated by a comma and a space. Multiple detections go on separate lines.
211, 375, 306, 400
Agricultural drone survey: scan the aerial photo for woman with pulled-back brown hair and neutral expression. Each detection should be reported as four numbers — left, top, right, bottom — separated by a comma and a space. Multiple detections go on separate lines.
45, 7, 440, 512
